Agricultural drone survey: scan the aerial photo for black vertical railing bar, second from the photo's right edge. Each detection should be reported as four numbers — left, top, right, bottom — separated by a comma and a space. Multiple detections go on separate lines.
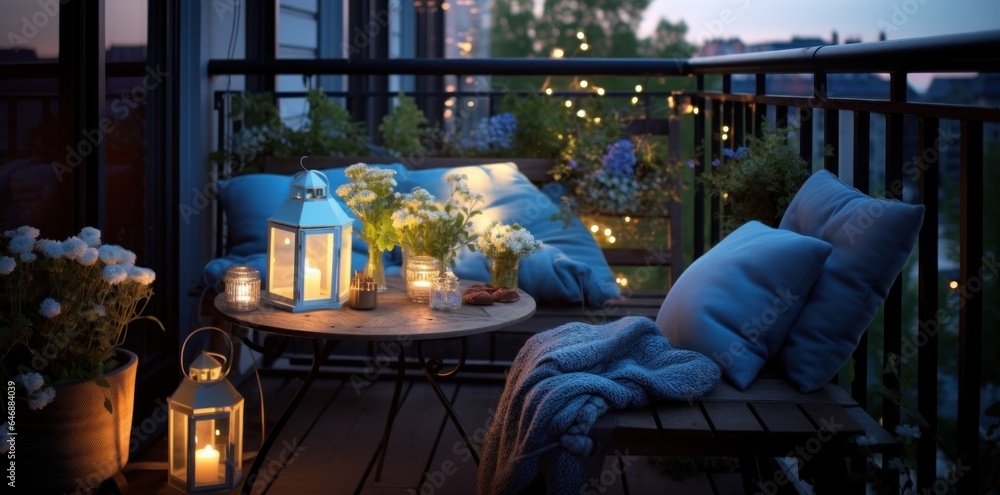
916, 118, 940, 493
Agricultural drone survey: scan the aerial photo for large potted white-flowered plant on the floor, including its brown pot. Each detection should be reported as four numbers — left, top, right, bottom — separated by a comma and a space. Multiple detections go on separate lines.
0, 226, 163, 491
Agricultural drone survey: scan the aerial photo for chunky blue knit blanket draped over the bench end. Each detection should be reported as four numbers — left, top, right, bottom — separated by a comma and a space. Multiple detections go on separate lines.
477, 317, 720, 495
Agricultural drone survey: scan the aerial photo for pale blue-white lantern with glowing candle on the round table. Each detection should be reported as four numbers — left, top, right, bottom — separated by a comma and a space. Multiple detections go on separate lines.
264, 170, 353, 312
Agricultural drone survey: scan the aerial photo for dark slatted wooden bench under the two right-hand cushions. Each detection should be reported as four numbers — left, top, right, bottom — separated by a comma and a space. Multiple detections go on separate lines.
592, 378, 899, 494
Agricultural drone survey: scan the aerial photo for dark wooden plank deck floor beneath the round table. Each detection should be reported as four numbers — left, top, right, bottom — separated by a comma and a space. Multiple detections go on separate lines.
125, 356, 741, 495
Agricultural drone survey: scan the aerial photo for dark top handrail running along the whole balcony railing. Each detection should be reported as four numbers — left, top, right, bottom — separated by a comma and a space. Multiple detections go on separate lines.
208, 30, 1000, 76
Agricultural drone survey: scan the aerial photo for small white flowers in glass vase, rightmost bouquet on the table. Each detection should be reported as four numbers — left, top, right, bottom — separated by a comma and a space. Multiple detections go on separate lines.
479, 221, 542, 289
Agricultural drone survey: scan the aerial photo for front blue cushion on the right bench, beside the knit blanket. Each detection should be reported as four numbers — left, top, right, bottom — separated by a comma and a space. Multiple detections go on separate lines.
656, 221, 832, 390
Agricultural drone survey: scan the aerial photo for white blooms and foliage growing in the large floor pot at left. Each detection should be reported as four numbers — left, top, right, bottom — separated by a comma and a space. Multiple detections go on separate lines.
0, 226, 163, 409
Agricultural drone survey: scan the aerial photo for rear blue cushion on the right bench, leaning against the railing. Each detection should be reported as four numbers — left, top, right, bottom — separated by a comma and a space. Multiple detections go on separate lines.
780, 170, 924, 392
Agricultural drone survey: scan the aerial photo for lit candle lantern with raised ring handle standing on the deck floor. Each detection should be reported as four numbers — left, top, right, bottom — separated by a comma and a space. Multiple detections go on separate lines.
167, 327, 243, 493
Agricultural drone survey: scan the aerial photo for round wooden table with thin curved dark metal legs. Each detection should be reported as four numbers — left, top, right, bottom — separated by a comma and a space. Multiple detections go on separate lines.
215, 277, 535, 494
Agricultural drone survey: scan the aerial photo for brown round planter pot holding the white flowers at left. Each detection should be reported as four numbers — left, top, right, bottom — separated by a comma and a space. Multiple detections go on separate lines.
16, 349, 139, 493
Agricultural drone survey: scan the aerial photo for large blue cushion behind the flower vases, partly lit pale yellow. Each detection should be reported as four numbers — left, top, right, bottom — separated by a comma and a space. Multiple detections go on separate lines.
399, 163, 620, 306
